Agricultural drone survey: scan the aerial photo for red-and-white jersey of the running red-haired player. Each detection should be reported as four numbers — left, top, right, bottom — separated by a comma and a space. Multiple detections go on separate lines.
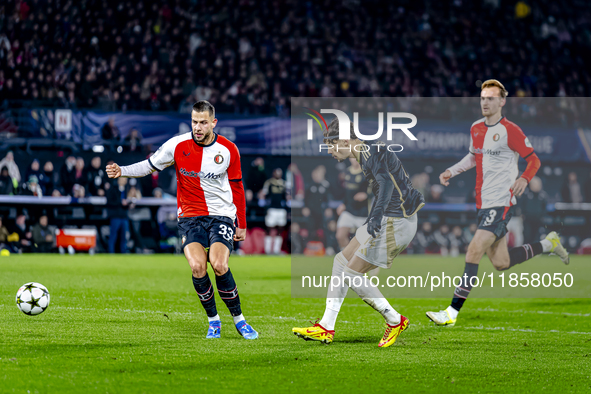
470, 117, 537, 209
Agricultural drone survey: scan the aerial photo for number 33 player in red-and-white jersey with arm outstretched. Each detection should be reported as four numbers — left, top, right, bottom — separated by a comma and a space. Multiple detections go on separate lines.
107, 101, 258, 339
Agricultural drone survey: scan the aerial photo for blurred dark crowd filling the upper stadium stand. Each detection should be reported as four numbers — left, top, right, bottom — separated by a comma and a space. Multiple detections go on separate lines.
0, 0, 591, 115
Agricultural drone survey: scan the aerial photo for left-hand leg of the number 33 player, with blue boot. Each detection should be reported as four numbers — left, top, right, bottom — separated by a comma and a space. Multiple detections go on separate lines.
183, 242, 222, 338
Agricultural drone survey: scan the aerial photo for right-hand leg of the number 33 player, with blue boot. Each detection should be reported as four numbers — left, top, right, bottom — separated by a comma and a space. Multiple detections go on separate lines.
209, 242, 259, 339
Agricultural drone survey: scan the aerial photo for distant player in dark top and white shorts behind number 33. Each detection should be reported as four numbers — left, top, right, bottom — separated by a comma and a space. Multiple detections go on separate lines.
262, 168, 287, 254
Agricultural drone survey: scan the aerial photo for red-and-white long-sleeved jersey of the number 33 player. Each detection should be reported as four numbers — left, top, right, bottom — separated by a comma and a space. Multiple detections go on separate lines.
148, 132, 246, 228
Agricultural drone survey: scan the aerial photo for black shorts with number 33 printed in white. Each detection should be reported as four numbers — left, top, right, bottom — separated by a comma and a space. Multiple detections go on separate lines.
178, 216, 236, 252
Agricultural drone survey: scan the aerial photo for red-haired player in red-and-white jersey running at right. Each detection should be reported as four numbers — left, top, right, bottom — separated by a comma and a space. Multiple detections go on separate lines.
427, 79, 569, 326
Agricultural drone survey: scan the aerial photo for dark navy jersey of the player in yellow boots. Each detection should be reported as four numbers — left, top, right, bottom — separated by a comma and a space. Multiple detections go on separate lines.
358, 142, 425, 217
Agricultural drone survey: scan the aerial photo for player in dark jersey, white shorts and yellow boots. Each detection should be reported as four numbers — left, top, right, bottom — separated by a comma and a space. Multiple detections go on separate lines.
292, 119, 425, 347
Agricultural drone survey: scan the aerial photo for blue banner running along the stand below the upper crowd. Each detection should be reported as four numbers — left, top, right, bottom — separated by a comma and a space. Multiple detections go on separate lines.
20, 110, 590, 162
